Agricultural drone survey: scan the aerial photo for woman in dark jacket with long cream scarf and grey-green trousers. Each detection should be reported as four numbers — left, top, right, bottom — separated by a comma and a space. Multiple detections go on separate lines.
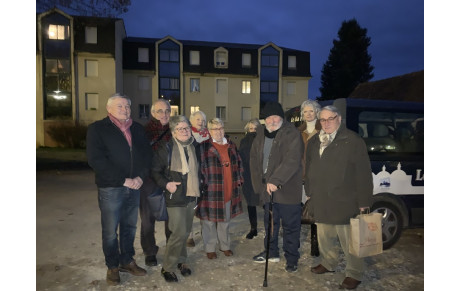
152, 115, 200, 282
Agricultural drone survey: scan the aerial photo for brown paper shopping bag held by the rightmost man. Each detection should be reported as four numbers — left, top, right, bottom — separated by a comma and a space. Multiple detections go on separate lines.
348, 213, 383, 258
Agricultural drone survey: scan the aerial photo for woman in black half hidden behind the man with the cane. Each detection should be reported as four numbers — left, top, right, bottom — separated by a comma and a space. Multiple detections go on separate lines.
239, 118, 260, 239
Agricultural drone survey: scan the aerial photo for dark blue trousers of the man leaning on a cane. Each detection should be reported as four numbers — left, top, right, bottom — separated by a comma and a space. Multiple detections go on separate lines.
264, 203, 302, 266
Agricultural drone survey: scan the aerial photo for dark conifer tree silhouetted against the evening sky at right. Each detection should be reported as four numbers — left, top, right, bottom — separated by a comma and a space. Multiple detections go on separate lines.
318, 19, 374, 100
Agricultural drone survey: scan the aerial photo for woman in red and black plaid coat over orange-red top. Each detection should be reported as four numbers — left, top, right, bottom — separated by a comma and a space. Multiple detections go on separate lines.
196, 118, 243, 260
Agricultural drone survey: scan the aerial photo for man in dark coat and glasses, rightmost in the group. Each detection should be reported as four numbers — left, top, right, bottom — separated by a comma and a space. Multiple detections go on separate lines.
305, 106, 373, 289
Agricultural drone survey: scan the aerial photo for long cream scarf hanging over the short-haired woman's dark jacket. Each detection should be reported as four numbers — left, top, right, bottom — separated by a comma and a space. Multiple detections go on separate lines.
171, 136, 200, 197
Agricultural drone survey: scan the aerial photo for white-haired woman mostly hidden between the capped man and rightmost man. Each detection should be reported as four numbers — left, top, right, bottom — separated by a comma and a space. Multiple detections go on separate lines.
299, 100, 321, 257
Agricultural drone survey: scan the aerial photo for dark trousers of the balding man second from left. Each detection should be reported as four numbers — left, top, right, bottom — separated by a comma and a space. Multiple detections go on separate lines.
139, 178, 171, 256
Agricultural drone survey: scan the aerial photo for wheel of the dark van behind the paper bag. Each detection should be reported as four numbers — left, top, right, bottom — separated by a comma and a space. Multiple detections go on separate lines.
372, 201, 403, 250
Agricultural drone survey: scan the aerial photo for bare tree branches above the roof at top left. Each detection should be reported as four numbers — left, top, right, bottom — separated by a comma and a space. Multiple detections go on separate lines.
36, 0, 131, 17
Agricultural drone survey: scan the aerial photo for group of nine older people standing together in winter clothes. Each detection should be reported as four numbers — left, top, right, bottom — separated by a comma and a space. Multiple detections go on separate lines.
87, 94, 372, 289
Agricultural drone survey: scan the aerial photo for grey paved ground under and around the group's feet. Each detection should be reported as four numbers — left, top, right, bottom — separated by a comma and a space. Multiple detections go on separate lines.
36, 167, 424, 290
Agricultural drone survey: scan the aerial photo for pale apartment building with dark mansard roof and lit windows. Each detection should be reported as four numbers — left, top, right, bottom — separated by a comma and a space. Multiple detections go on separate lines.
36, 9, 311, 146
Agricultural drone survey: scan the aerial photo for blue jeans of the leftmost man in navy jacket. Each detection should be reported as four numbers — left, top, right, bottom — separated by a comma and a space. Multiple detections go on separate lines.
98, 187, 139, 269
